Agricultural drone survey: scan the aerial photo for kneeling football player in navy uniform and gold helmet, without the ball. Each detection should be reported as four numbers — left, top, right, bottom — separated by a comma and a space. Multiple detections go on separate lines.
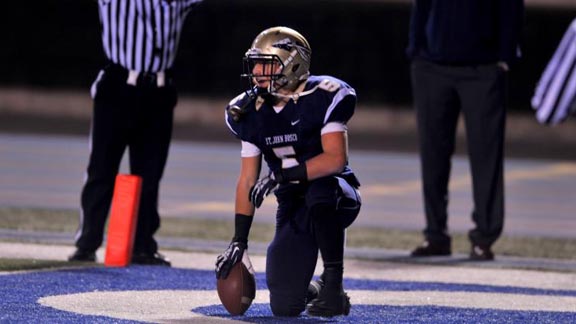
216, 27, 361, 317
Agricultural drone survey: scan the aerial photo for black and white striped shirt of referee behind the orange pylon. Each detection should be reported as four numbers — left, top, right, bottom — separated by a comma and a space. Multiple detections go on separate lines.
98, 0, 202, 73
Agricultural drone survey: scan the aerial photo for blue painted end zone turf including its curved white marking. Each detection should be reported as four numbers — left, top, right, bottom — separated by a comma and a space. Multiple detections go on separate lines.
0, 266, 576, 323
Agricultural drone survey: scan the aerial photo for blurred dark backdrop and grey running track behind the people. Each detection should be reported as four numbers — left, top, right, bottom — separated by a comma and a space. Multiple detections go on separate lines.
0, 0, 576, 255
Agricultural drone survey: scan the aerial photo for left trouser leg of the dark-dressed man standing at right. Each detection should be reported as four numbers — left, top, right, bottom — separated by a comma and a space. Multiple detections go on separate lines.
411, 61, 460, 243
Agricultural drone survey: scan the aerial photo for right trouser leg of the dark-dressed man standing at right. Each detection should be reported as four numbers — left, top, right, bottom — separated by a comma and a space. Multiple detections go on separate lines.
458, 64, 506, 246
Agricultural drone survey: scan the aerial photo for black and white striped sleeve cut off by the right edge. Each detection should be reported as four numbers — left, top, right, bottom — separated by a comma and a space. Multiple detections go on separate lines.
532, 19, 576, 125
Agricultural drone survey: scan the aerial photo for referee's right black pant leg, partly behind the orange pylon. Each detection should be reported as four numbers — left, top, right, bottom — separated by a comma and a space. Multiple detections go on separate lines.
129, 87, 176, 253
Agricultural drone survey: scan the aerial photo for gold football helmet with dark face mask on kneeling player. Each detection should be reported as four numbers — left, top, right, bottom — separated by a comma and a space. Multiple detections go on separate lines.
242, 27, 312, 94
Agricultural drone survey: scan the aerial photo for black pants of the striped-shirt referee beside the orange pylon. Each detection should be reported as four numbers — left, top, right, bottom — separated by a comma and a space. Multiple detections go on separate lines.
76, 65, 177, 253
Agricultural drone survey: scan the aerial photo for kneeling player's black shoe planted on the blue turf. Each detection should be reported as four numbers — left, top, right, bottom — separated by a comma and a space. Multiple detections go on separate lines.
306, 289, 350, 317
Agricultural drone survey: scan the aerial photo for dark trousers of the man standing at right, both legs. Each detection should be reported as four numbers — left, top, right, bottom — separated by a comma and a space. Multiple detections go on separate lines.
411, 60, 507, 246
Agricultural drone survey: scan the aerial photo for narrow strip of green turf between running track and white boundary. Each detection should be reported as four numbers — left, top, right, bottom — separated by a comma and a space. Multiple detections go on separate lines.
0, 208, 576, 260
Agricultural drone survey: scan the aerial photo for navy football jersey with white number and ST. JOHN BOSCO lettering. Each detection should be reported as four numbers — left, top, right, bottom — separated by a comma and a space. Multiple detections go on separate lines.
226, 76, 356, 177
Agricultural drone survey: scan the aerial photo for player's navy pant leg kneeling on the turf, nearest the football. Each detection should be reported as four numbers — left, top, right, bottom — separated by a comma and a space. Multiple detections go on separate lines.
266, 192, 318, 316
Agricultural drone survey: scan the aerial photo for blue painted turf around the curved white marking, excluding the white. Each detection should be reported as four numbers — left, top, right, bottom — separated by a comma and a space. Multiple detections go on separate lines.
0, 266, 576, 324
